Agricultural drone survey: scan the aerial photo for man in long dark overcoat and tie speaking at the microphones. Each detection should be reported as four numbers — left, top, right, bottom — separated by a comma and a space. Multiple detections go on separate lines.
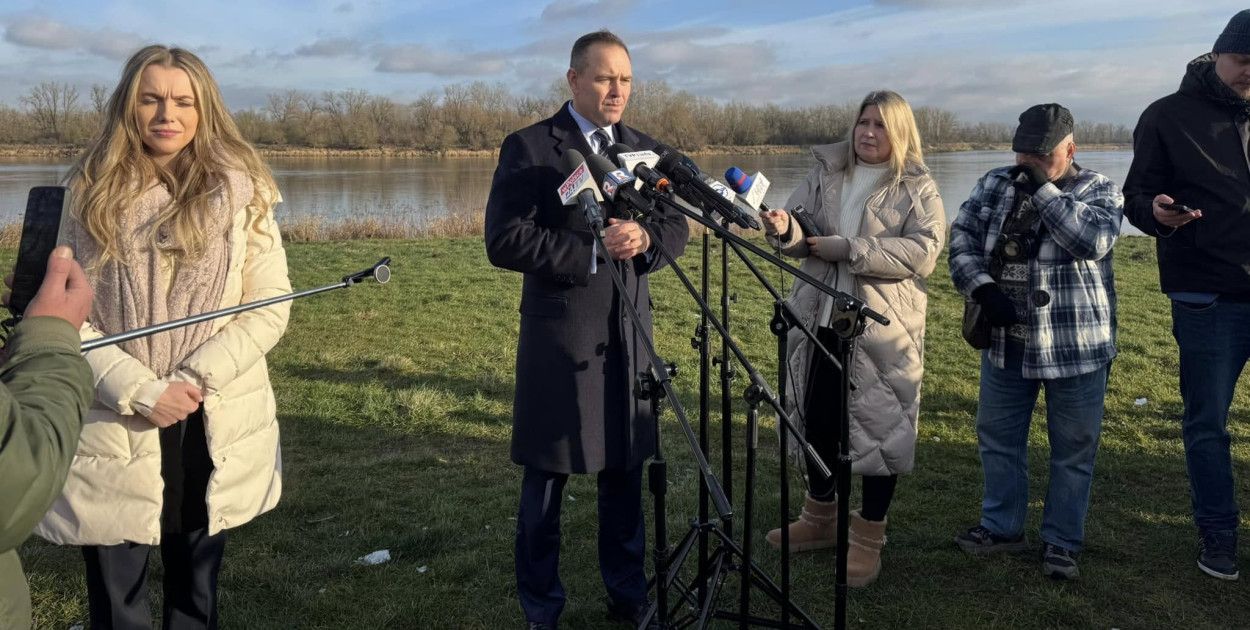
486, 31, 689, 629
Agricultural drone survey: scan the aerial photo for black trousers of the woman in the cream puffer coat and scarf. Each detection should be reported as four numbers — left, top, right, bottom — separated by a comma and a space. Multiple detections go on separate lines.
83, 408, 226, 630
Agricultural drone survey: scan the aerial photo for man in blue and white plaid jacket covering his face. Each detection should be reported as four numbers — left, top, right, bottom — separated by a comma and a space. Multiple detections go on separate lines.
950, 104, 1124, 579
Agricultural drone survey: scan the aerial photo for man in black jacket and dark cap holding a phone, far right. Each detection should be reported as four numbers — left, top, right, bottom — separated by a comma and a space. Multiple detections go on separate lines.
1124, 10, 1250, 580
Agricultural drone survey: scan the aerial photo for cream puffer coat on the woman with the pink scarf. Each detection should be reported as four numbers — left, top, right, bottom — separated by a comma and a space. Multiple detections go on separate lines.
35, 193, 291, 545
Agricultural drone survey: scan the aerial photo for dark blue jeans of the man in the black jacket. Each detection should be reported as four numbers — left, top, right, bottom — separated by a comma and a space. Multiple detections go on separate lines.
1173, 300, 1250, 531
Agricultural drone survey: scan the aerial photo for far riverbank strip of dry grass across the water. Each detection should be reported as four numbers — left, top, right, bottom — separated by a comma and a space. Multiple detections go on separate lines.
0, 143, 1133, 159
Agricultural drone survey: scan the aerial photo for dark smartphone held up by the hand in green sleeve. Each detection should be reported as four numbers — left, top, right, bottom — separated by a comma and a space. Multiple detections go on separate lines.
9, 186, 70, 318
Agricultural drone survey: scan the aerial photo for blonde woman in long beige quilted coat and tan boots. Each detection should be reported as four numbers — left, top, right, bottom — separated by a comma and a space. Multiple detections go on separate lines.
763, 91, 946, 586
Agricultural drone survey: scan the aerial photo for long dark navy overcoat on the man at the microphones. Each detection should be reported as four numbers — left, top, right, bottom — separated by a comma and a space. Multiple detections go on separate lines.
486, 105, 689, 473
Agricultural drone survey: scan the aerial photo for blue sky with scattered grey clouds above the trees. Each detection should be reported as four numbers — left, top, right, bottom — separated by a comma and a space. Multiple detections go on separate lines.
0, 0, 1245, 126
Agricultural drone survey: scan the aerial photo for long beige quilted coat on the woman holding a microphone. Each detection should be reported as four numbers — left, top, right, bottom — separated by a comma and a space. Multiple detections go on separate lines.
769, 143, 946, 475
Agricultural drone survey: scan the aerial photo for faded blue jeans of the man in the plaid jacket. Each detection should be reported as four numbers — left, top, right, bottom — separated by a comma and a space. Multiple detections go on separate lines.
976, 353, 1108, 551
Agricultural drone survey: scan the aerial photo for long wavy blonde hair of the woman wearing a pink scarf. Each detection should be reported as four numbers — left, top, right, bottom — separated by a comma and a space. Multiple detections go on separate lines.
66, 45, 278, 265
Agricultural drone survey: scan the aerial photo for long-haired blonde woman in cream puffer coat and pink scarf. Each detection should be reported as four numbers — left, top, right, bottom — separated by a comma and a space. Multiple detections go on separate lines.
36, 46, 291, 630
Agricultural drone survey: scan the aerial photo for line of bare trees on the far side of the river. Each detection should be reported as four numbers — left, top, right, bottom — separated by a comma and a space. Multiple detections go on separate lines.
0, 80, 1133, 151
